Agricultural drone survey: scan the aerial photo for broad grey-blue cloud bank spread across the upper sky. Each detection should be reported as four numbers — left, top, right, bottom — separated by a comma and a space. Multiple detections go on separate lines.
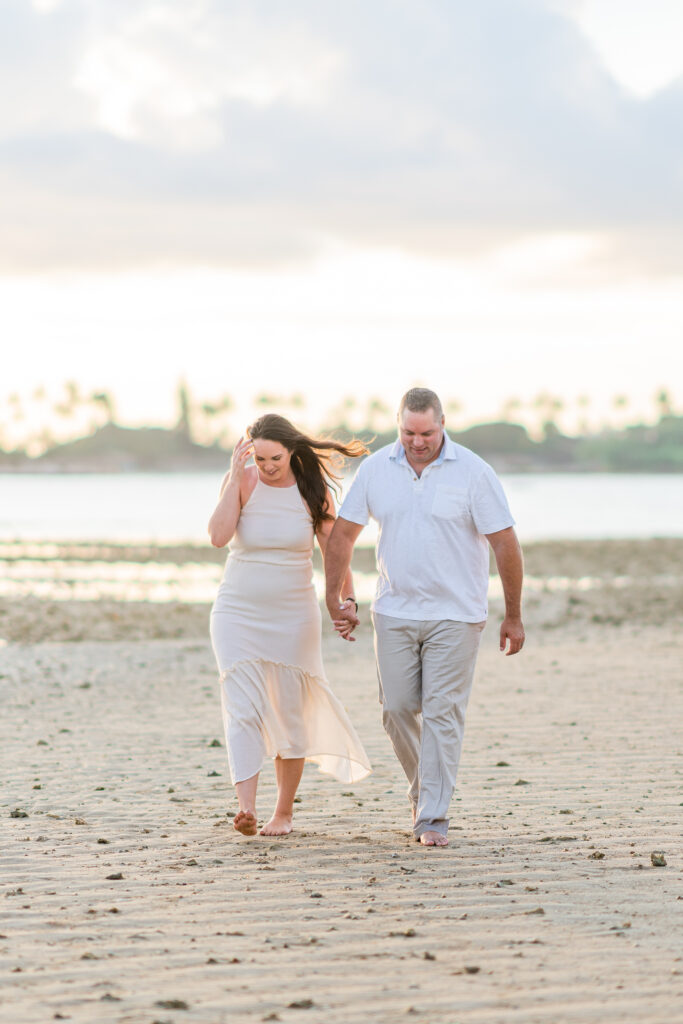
0, 0, 683, 272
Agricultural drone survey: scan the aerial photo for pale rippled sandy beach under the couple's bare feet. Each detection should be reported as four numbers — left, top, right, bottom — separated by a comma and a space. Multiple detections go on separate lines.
0, 541, 683, 1024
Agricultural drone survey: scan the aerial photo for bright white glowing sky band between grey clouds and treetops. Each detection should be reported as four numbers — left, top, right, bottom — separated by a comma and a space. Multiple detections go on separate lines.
0, 236, 683, 450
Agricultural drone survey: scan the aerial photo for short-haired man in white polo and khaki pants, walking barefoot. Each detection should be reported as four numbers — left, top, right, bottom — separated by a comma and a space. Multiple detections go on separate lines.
325, 388, 524, 846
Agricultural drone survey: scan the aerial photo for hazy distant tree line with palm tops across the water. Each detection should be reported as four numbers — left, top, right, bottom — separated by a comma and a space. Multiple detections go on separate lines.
0, 381, 683, 471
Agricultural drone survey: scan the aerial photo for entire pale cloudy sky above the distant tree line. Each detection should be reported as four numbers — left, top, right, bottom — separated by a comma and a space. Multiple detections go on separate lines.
0, 0, 683, 442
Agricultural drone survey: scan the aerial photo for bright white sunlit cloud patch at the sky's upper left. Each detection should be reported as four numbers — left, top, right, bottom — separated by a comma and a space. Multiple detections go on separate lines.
74, 0, 343, 151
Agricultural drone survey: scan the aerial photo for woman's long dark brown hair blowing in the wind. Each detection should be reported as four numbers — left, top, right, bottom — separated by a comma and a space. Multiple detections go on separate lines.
247, 413, 369, 529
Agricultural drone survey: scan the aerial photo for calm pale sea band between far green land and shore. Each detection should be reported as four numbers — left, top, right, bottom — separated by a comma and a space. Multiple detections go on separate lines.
0, 473, 683, 544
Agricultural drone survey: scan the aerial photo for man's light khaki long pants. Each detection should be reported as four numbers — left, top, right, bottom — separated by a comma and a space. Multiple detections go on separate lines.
373, 612, 485, 839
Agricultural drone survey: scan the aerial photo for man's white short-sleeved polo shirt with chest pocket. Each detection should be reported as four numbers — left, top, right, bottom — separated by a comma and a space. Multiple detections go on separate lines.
339, 434, 514, 623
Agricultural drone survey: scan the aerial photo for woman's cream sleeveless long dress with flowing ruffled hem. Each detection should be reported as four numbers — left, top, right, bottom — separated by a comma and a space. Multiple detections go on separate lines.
211, 478, 371, 782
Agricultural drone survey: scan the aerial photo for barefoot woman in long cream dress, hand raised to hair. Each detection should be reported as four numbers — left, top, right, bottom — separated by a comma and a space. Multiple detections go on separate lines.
209, 414, 370, 836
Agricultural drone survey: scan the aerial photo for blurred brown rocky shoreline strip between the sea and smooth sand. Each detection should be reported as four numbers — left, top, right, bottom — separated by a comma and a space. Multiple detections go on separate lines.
0, 539, 683, 644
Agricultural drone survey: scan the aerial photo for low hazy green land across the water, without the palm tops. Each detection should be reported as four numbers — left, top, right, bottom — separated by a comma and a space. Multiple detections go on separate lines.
0, 415, 683, 473
